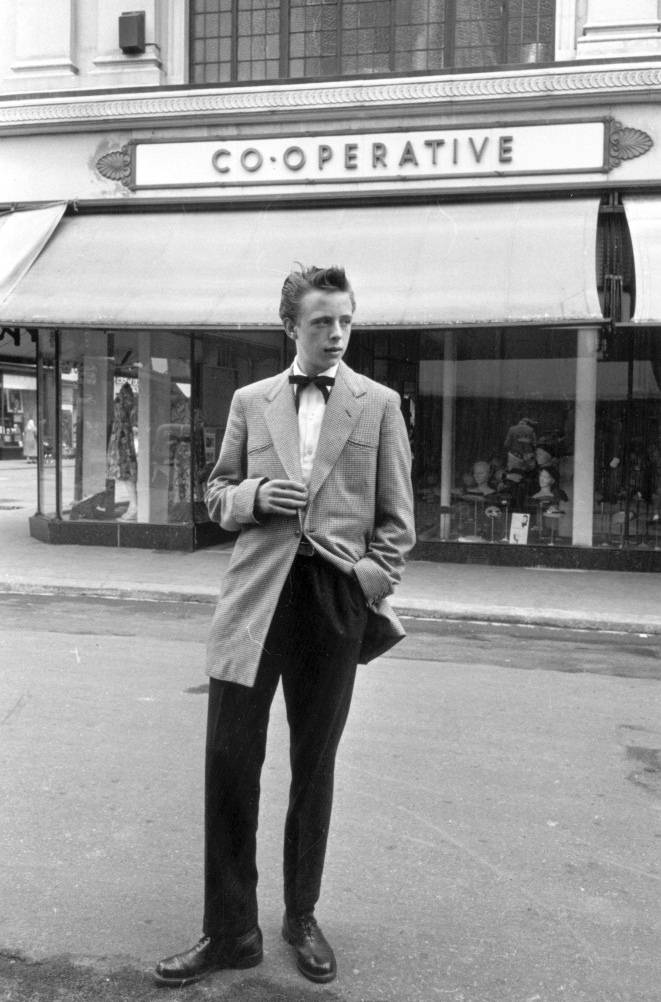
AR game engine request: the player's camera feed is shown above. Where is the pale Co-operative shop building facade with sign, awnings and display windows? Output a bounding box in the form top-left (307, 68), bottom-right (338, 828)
top-left (0, 0), bottom-right (661, 570)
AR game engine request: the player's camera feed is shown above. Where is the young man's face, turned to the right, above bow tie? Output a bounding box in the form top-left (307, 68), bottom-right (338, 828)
top-left (287, 289), bottom-right (354, 376)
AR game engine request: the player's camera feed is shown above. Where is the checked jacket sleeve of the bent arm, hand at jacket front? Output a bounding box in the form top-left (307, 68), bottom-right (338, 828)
top-left (204, 392), bottom-right (264, 532)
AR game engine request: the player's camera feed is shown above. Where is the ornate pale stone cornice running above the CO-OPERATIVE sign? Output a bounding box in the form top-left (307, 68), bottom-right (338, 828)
top-left (0, 60), bottom-right (661, 134)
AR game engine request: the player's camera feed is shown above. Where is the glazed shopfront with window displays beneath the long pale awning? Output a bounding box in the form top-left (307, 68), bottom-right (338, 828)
top-left (32, 327), bottom-right (661, 559)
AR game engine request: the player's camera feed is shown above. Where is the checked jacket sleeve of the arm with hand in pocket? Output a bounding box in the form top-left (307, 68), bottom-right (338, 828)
top-left (354, 394), bottom-right (416, 605)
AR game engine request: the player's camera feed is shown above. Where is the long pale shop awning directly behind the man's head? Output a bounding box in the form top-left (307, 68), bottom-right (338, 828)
top-left (0, 198), bottom-right (602, 328)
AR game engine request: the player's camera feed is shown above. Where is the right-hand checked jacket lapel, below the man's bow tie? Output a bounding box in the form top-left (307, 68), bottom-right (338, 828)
top-left (308, 362), bottom-right (366, 504)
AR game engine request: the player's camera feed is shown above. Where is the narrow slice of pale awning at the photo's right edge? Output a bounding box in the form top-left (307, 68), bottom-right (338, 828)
top-left (622, 195), bottom-right (661, 325)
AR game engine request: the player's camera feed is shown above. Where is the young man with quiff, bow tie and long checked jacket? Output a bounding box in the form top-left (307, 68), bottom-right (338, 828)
top-left (155, 268), bottom-right (415, 987)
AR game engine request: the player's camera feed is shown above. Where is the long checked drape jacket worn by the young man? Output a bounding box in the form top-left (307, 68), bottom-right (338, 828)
top-left (205, 362), bottom-right (415, 685)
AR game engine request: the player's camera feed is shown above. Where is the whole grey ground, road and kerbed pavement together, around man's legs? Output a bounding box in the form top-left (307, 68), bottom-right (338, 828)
top-left (0, 464), bottom-right (661, 1002)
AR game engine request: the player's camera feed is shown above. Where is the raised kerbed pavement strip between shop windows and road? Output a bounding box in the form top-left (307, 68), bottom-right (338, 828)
top-left (0, 461), bottom-right (661, 634)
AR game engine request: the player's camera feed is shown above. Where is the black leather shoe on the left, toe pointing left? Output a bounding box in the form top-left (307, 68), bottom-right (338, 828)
top-left (154, 926), bottom-right (262, 988)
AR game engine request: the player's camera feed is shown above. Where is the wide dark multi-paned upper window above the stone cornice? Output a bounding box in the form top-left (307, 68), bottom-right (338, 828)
top-left (190, 0), bottom-right (555, 83)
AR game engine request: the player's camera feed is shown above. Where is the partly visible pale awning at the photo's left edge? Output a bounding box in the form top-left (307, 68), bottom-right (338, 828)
top-left (0, 202), bottom-right (66, 303)
